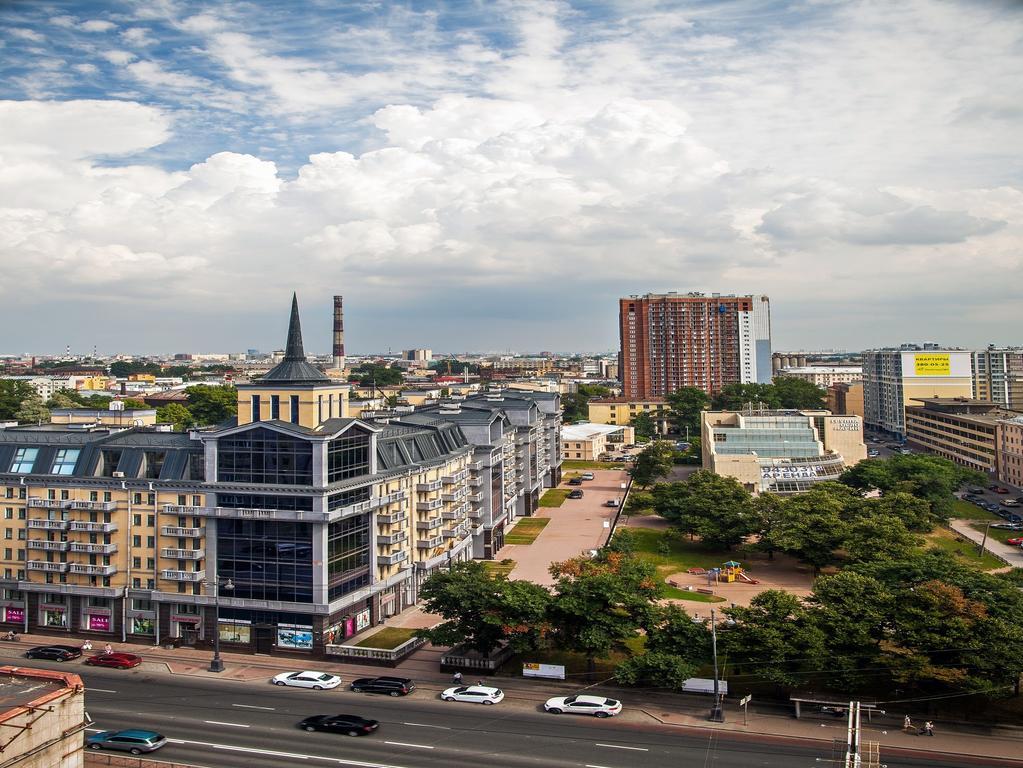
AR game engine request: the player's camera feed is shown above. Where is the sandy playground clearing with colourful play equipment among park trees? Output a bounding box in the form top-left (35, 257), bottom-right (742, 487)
top-left (667, 555), bottom-right (812, 605)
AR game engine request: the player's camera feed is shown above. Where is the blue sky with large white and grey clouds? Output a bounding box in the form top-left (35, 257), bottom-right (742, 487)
top-left (0, 0), bottom-right (1023, 354)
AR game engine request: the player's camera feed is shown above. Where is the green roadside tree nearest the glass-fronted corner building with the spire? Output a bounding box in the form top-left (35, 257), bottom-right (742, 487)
top-left (420, 560), bottom-right (550, 654)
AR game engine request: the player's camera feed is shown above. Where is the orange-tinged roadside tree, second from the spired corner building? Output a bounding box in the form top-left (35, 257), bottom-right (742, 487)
top-left (547, 549), bottom-right (661, 672)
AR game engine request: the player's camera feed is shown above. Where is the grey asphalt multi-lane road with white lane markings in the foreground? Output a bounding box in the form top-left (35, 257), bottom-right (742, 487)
top-left (0, 650), bottom-right (1002, 768)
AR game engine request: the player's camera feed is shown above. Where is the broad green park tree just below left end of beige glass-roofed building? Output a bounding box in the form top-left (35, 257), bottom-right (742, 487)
top-left (653, 469), bottom-right (757, 549)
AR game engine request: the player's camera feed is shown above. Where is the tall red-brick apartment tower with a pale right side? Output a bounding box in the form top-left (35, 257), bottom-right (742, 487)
top-left (619, 292), bottom-right (771, 400)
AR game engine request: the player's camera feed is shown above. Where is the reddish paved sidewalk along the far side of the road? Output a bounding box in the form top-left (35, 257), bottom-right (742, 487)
top-left (0, 635), bottom-right (1023, 766)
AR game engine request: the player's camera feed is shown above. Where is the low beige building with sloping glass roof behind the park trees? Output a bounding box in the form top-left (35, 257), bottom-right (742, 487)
top-left (701, 410), bottom-right (866, 495)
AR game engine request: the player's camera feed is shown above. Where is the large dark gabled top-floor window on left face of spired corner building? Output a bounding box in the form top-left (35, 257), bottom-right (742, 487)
top-left (217, 428), bottom-right (313, 486)
